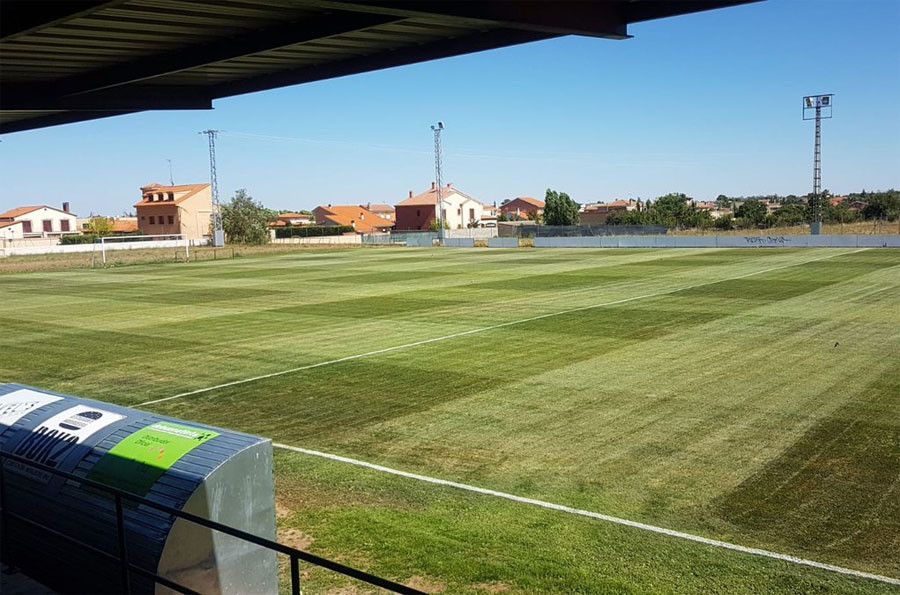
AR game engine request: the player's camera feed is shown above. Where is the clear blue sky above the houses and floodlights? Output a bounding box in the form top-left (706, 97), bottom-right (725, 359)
top-left (0, 0), bottom-right (900, 215)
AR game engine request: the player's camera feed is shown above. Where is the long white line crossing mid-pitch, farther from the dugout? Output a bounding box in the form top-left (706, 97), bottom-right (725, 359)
top-left (135, 248), bottom-right (868, 407)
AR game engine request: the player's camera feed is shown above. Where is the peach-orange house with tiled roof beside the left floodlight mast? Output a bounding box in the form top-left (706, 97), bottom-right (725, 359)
top-left (134, 184), bottom-right (212, 240)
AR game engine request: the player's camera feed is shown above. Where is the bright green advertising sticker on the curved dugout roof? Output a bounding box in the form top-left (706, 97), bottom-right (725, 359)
top-left (88, 421), bottom-right (219, 496)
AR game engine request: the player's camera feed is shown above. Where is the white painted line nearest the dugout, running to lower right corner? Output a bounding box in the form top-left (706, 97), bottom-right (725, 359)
top-left (273, 442), bottom-right (900, 585)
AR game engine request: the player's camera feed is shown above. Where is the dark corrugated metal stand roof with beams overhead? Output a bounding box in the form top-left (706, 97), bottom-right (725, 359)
top-left (0, 0), bottom-right (756, 133)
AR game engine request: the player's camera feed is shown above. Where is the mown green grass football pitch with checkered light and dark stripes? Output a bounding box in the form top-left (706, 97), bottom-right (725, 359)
top-left (0, 249), bottom-right (900, 593)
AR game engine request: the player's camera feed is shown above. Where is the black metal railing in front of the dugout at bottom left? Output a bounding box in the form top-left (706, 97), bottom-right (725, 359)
top-left (0, 452), bottom-right (424, 595)
